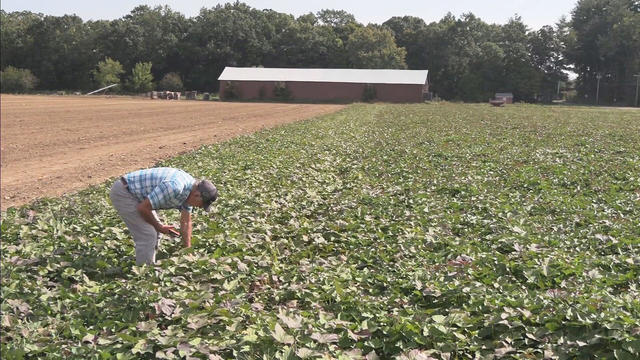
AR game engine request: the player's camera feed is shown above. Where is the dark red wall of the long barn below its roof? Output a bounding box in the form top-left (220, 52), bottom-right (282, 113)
top-left (220, 81), bottom-right (423, 102)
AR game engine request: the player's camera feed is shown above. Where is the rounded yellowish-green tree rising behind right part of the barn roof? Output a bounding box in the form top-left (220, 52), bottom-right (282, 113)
top-left (345, 25), bottom-right (407, 69)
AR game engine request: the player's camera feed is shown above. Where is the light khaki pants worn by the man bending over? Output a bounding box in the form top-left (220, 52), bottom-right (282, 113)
top-left (109, 179), bottom-right (161, 265)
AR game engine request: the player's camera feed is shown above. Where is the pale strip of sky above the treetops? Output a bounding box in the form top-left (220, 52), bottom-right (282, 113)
top-left (0, 0), bottom-right (577, 30)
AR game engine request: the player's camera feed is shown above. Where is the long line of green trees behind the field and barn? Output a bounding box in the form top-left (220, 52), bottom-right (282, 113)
top-left (0, 0), bottom-right (640, 105)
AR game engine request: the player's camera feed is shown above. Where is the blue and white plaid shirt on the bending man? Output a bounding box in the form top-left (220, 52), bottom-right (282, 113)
top-left (124, 168), bottom-right (196, 212)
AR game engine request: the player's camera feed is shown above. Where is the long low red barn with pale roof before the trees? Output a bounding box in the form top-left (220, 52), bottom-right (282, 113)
top-left (218, 67), bottom-right (429, 102)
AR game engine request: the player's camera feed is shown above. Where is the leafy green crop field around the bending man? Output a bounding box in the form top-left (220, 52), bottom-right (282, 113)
top-left (0, 103), bottom-right (640, 359)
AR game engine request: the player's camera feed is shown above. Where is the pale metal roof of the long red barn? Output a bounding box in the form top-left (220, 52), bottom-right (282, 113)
top-left (218, 66), bottom-right (429, 85)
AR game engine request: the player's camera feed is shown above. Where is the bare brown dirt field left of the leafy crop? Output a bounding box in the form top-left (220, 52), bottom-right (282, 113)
top-left (0, 95), bottom-right (344, 210)
